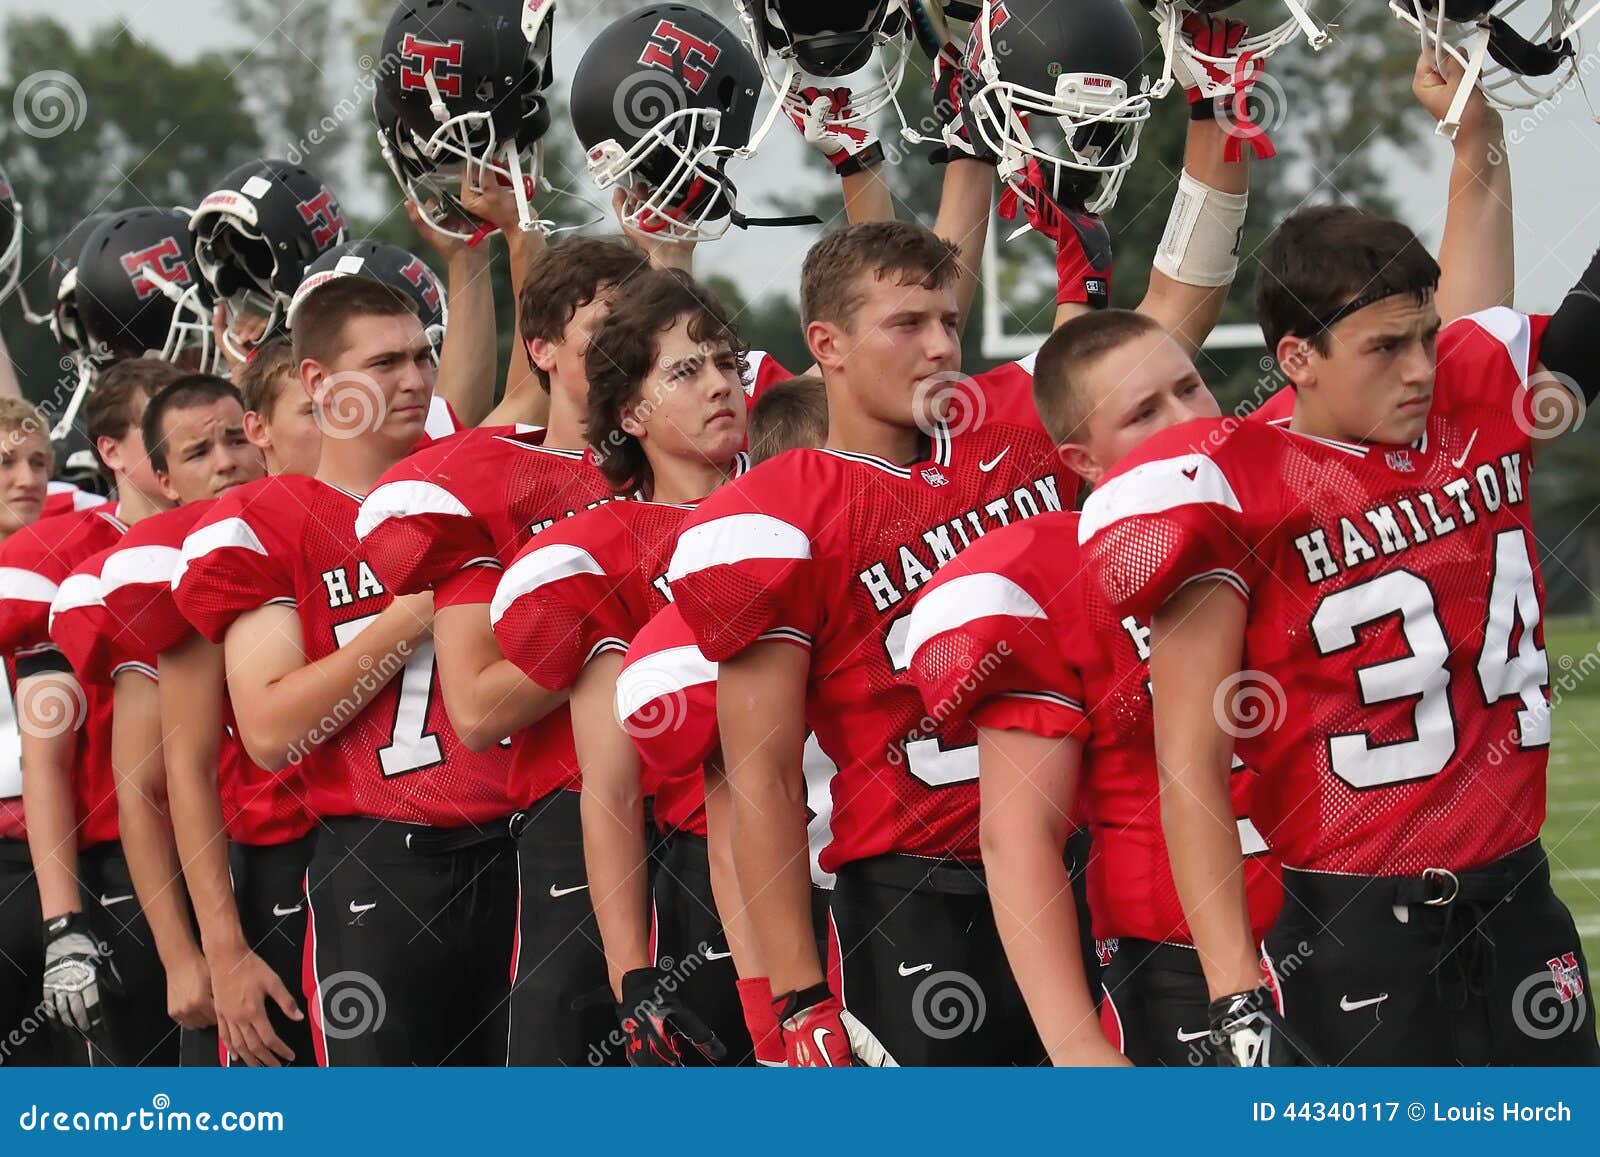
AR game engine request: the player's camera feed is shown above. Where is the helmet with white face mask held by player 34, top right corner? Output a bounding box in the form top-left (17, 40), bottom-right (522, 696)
top-left (1389, 0), bottom-right (1580, 138)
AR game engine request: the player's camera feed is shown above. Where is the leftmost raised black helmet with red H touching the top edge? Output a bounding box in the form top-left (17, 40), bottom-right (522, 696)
top-left (373, 0), bottom-right (555, 237)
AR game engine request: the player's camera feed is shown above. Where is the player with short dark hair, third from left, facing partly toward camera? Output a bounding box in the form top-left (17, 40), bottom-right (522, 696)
top-left (50, 374), bottom-right (266, 1066)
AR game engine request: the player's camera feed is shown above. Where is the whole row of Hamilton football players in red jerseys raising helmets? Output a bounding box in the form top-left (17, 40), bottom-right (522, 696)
top-left (0, 0), bottom-right (1600, 1066)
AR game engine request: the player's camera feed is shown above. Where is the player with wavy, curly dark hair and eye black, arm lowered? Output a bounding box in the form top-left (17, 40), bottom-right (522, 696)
top-left (490, 270), bottom-right (750, 1064)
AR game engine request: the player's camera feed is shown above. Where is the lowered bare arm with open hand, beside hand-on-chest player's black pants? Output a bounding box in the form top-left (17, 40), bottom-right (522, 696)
top-left (160, 634), bottom-right (304, 1066)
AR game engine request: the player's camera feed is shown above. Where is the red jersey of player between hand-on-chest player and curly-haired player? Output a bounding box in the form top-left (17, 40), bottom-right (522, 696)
top-left (355, 427), bottom-right (616, 803)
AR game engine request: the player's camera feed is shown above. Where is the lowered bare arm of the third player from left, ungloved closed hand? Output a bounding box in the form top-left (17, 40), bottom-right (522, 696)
top-left (110, 671), bottom-right (216, 1029)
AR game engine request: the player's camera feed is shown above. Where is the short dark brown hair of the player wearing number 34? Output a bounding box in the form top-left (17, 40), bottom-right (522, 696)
top-left (1256, 205), bottom-right (1438, 355)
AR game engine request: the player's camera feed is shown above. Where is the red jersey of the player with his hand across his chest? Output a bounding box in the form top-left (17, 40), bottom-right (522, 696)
top-left (173, 475), bottom-right (512, 827)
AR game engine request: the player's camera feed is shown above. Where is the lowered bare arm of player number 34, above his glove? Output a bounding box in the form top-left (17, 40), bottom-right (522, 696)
top-left (1150, 583), bottom-right (1261, 1000)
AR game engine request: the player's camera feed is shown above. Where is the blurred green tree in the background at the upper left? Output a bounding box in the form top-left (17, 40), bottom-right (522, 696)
top-left (0, 16), bottom-right (261, 412)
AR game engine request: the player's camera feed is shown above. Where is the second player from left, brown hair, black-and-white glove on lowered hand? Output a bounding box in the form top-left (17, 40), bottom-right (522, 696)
top-left (0, 358), bottom-right (182, 1066)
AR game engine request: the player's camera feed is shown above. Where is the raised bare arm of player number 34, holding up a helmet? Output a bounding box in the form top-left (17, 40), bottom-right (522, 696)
top-left (1411, 53), bottom-right (1517, 323)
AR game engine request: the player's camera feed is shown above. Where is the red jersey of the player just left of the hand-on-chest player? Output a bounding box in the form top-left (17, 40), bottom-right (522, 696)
top-left (99, 499), bottom-right (315, 845)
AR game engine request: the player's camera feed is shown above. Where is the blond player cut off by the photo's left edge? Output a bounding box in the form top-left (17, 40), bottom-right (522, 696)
top-left (0, 397), bottom-right (85, 1064)
